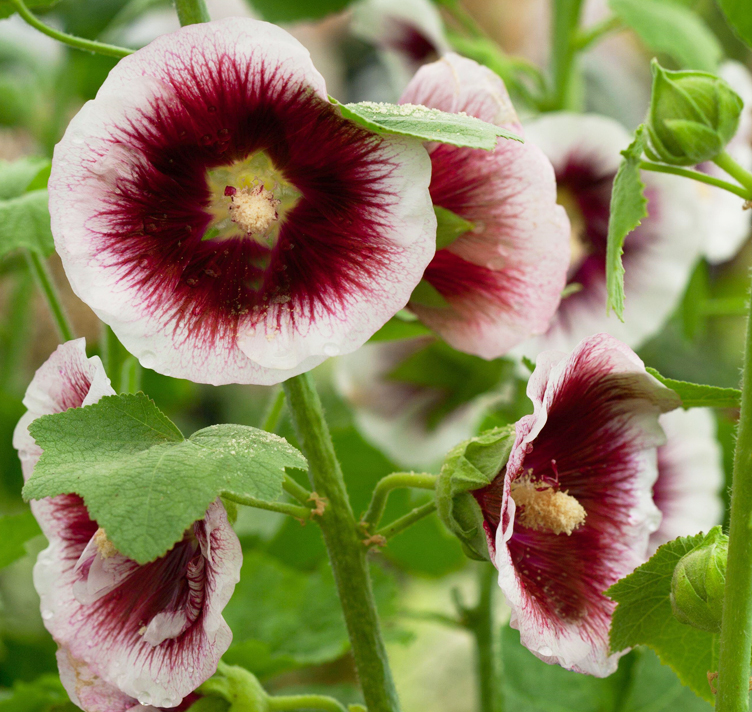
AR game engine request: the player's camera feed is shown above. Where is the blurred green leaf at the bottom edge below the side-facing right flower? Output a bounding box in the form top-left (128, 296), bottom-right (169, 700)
top-left (501, 627), bottom-right (711, 712)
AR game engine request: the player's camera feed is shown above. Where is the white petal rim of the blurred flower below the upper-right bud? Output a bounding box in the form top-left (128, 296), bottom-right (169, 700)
top-left (519, 112), bottom-right (706, 357)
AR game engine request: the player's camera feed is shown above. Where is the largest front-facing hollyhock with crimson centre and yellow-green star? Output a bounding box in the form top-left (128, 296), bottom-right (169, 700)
top-left (49, 18), bottom-right (436, 384)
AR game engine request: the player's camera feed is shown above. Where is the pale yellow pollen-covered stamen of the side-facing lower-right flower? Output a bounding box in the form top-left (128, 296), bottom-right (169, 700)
top-left (511, 473), bottom-right (587, 536)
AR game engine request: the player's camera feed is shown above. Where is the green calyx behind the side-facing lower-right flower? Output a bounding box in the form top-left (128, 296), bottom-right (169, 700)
top-left (436, 426), bottom-right (515, 561)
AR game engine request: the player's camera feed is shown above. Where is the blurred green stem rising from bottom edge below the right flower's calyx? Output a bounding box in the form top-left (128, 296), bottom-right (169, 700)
top-left (464, 564), bottom-right (503, 712)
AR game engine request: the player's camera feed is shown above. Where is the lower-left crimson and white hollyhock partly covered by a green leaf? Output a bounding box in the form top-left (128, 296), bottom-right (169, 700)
top-left (13, 339), bottom-right (242, 712)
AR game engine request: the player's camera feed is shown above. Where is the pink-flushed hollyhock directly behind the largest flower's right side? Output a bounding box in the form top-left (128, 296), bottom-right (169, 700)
top-left (401, 54), bottom-right (569, 359)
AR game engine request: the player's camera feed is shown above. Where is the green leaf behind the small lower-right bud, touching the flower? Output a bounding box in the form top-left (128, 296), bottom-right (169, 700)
top-left (606, 534), bottom-right (718, 702)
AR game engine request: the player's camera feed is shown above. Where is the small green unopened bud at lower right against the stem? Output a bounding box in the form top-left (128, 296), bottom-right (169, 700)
top-left (671, 527), bottom-right (728, 633)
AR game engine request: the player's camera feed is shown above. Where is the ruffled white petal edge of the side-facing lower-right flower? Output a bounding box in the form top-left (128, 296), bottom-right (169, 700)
top-left (494, 334), bottom-right (680, 677)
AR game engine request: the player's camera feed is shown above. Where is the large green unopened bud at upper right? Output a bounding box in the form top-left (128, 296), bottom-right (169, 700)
top-left (645, 60), bottom-right (744, 166)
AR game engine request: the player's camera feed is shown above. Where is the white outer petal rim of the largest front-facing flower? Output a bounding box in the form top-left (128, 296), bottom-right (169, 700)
top-left (49, 18), bottom-right (436, 385)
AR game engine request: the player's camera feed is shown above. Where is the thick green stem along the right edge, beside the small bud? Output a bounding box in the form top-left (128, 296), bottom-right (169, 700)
top-left (715, 286), bottom-right (752, 712)
